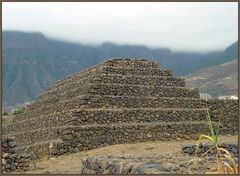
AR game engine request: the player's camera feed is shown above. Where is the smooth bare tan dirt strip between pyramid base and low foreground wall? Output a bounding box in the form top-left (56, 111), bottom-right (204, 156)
top-left (23, 136), bottom-right (238, 174)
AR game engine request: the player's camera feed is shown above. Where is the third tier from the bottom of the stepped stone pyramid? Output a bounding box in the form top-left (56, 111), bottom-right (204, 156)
top-left (7, 95), bottom-right (206, 125)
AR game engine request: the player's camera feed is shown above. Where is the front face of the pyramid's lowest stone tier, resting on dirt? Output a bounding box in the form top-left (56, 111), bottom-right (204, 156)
top-left (15, 121), bottom-right (208, 156)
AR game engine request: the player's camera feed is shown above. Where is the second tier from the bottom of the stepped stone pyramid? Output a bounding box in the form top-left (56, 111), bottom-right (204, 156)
top-left (3, 108), bottom-right (206, 135)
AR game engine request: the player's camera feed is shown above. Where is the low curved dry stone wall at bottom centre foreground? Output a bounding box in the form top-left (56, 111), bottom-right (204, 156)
top-left (81, 156), bottom-right (174, 175)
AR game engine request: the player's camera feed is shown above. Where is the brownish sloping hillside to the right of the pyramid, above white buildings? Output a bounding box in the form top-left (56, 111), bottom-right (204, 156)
top-left (185, 59), bottom-right (238, 97)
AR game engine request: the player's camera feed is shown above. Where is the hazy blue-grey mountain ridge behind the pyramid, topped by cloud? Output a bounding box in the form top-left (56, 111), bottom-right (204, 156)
top-left (2, 31), bottom-right (238, 108)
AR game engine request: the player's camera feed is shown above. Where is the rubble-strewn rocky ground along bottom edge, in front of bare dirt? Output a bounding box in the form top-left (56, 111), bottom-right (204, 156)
top-left (82, 153), bottom-right (237, 174)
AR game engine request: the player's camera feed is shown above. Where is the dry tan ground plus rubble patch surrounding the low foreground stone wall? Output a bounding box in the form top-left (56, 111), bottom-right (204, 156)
top-left (13, 136), bottom-right (238, 174)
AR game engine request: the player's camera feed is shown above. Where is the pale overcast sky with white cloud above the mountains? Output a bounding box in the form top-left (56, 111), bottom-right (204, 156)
top-left (2, 2), bottom-right (238, 52)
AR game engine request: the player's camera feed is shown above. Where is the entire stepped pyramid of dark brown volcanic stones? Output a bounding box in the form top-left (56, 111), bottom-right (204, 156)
top-left (3, 59), bottom-right (208, 158)
